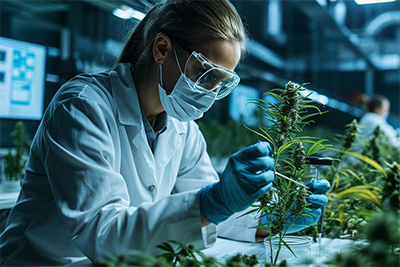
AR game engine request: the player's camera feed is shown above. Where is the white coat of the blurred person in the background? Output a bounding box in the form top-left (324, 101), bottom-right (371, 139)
top-left (359, 112), bottom-right (400, 147)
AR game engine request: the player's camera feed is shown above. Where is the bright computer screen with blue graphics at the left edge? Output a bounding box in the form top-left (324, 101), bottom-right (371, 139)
top-left (0, 37), bottom-right (46, 120)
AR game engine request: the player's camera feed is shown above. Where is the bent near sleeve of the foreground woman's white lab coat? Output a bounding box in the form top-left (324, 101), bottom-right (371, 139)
top-left (41, 97), bottom-right (209, 262)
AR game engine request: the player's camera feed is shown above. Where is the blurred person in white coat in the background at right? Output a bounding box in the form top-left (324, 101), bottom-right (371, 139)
top-left (359, 95), bottom-right (400, 147)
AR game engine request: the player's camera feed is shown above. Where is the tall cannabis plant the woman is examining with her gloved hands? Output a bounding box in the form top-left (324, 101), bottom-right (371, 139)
top-left (245, 82), bottom-right (332, 264)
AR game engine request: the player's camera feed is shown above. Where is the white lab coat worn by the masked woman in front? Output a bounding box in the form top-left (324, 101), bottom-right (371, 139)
top-left (0, 64), bottom-right (256, 265)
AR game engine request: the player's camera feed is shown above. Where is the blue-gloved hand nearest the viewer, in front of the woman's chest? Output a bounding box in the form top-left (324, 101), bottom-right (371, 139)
top-left (199, 142), bottom-right (275, 224)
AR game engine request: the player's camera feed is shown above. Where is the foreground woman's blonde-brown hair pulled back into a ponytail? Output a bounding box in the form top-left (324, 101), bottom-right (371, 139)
top-left (117, 0), bottom-right (246, 73)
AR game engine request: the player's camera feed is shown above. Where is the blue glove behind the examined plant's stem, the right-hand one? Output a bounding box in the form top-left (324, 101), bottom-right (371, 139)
top-left (261, 179), bottom-right (331, 234)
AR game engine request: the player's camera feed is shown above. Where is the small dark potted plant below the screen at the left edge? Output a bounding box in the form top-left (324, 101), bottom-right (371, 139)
top-left (4, 121), bottom-right (30, 192)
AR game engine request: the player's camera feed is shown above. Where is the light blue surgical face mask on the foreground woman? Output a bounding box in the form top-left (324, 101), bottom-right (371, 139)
top-left (158, 46), bottom-right (217, 122)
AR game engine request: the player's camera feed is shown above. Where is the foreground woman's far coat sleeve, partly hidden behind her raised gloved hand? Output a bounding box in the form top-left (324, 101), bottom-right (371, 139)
top-left (175, 122), bottom-right (257, 242)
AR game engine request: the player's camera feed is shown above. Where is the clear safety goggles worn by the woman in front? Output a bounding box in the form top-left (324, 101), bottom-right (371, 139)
top-left (182, 51), bottom-right (240, 99)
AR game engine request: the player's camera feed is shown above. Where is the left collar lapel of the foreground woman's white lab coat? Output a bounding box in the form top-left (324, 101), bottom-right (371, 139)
top-left (110, 63), bottom-right (142, 127)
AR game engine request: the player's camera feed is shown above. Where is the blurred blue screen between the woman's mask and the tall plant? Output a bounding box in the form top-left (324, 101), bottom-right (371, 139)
top-left (229, 84), bottom-right (260, 125)
